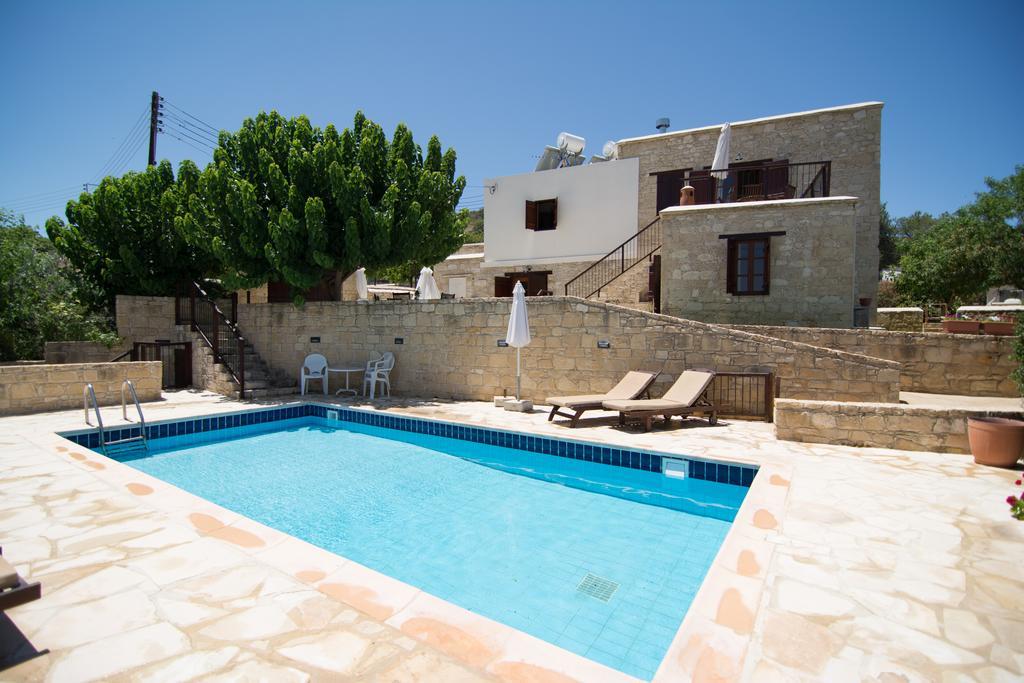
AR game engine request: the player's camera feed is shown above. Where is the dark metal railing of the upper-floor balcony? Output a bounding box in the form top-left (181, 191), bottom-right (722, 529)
top-left (685, 161), bottom-right (831, 204)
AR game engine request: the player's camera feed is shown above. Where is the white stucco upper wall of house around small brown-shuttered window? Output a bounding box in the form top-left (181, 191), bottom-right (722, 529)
top-left (483, 159), bottom-right (640, 263)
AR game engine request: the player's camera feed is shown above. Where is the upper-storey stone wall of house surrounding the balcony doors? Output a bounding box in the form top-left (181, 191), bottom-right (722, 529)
top-left (618, 102), bottom-right (882, 321)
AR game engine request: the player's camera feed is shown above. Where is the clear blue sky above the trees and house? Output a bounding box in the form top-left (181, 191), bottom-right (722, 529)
top-left (0, 0), bottom-right (1024, 225)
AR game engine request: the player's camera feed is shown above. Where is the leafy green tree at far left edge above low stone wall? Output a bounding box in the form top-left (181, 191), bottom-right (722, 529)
top-left (0, 209), bottom-right (117, 360)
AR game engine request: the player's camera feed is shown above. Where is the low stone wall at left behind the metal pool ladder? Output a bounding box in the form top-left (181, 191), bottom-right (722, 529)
top-left (0, 360), bottom-right (162, 415)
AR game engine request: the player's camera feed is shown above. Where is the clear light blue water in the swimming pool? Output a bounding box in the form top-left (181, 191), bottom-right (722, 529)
top-left (119, 417), bottom-right (746, 679)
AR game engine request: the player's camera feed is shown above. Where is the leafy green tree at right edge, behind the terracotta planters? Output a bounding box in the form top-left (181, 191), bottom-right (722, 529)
top-left (896, 166), bottom-right (1024, 305)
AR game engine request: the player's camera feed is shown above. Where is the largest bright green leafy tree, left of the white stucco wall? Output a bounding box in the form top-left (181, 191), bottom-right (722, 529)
top-left (177, 112), bottom-right (467, 300)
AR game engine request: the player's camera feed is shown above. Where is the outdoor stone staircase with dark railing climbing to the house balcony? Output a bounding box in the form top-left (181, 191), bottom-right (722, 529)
top-left (565, 217), bottom-right (662, 310)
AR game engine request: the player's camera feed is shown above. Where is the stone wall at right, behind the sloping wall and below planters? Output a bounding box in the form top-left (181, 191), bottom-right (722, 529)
top-left (733, 326), bottom-right (1020, 397)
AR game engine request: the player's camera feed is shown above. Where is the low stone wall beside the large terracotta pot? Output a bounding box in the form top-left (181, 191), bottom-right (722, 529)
top-left (775, 399), bottom-right (1024, 453)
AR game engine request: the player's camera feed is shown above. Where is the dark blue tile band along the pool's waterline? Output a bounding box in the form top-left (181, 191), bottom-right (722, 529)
top-left (59, 402), bottom-right (758, 487)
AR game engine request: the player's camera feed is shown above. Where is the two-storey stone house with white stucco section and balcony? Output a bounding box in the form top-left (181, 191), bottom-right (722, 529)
top-left (434, 102), bottom-right (883, 327)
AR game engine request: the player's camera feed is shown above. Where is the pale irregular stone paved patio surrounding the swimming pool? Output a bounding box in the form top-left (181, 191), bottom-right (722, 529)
top-left (0, 392), bottom-right (1024, 681)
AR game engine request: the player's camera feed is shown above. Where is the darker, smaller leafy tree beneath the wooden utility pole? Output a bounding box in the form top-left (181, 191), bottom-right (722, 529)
top-left (46, 161), bottom-right (213, 305)
